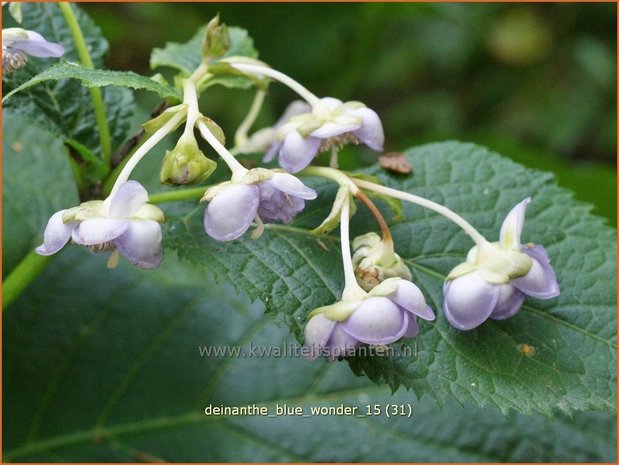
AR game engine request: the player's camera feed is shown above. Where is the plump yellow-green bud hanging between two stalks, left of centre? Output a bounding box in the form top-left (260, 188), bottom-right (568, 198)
top-left (159, 137), bottom-right (217, 186)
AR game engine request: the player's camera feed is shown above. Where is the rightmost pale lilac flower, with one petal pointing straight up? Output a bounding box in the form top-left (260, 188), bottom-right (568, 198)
top-left (443, 198), bottom-right (559, 330)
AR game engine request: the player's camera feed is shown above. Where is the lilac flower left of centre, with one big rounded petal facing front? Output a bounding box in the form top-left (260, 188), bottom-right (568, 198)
top-left (204, 173), bottom-right (317, 241)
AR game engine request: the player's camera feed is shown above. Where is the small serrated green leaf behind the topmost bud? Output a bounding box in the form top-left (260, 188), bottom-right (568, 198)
top-left (150, 26), bottom-right (258, 89)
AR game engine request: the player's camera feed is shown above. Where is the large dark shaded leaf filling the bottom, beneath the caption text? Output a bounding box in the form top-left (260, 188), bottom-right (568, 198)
top-left (3, 248), bottom-right (616, 462)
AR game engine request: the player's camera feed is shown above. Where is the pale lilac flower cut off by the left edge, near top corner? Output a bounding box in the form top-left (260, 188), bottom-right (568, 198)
top-left (2, 27), bottom-right (64, 71)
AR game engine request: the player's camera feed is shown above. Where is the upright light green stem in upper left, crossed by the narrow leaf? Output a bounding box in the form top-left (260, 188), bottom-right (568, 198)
top-left (58, 2), bottom-right (112, 166)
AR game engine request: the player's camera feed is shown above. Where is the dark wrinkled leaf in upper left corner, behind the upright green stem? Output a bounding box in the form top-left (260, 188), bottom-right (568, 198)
top-left (2, 2), bottom-right (133, 153)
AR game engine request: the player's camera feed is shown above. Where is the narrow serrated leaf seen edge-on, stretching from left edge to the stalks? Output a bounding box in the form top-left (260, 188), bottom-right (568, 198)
top-left (2, 63), bottom-right (181, 103)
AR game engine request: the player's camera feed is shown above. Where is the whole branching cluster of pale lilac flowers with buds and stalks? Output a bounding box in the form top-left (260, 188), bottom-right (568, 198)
top-left (21, 10), bottom-right (559, 359)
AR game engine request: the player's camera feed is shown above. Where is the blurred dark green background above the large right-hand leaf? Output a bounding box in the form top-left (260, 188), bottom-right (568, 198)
top-left (82, 3), bottom-right (617, 225)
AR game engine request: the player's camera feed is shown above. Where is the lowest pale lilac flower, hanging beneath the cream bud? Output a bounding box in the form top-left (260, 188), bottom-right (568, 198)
top-left (305, 278), bottom-right (435, 360)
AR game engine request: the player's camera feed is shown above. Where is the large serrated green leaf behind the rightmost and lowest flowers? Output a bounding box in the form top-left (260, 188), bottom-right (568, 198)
top-left (167, 143), bottom-right (616, 415)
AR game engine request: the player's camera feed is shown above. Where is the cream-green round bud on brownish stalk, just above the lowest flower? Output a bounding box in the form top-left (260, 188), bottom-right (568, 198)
top-left (352, 232), bottom-right (411, 291)
